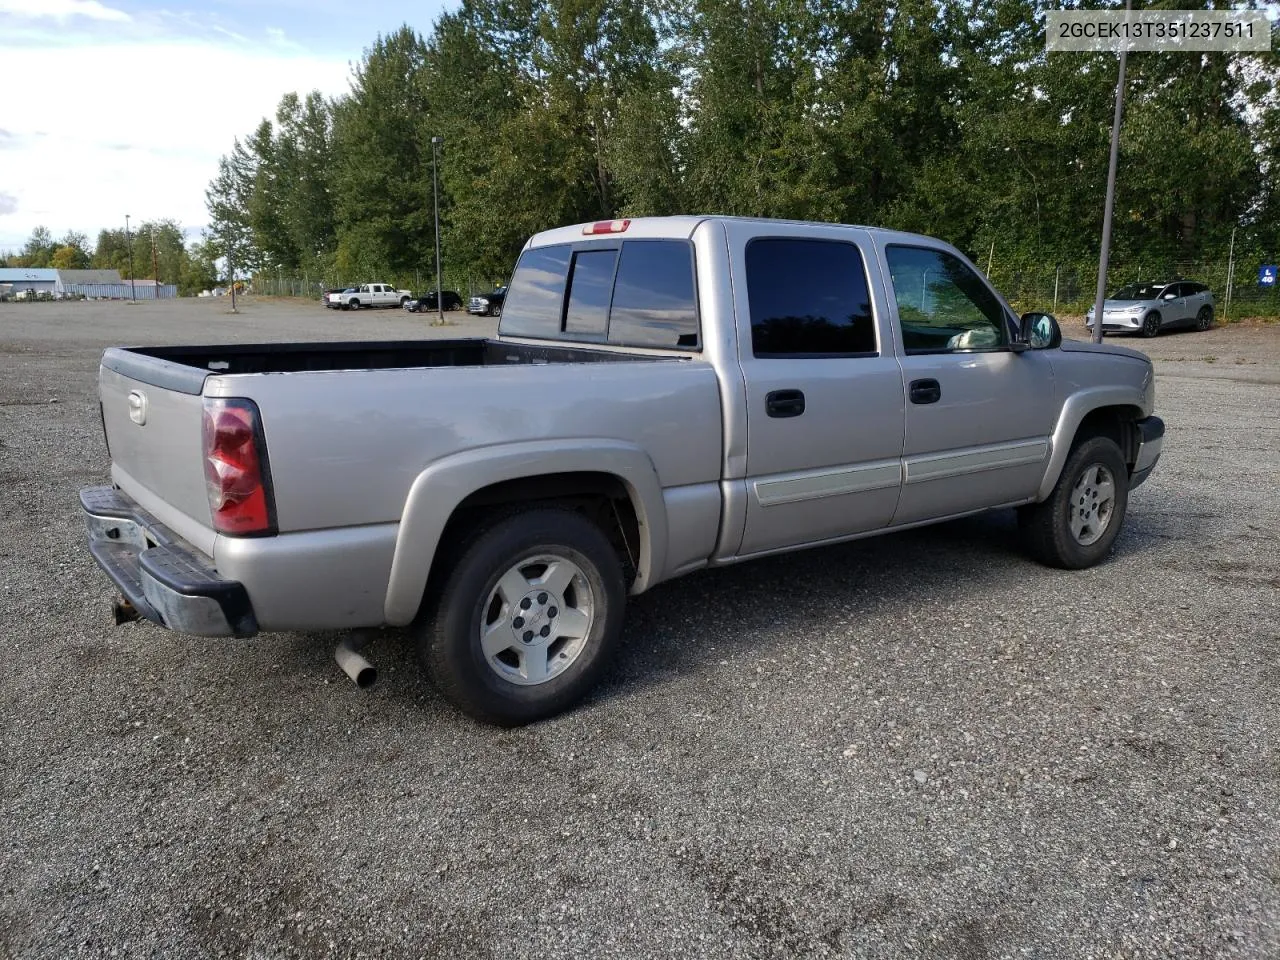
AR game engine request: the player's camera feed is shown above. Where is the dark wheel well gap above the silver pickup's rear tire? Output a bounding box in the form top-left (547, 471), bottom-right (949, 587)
top-left (428, 471), bottom-right (640, 601)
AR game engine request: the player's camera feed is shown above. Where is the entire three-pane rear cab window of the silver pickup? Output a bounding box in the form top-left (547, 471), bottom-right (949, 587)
top-left (499, 239), bottom-right (700, 349)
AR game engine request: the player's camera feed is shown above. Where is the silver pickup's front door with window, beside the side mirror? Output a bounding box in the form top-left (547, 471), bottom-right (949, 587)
top-left (883, 244), bottom-right (1055, 525)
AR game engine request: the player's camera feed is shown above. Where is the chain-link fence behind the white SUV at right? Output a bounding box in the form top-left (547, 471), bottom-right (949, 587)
top-left (978, 257), bottom-right (1280, 320)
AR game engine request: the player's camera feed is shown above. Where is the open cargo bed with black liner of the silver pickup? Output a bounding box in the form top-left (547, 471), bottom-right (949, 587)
top-left (102, 338), bottom-right (663, 394)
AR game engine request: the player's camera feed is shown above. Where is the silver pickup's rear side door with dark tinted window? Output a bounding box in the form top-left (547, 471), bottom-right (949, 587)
top-left (726, 221), bottom-right (904, 556)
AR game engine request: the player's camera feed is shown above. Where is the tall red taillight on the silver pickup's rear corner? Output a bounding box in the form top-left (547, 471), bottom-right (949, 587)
top-left (205, 398), bottom-right (275, 536)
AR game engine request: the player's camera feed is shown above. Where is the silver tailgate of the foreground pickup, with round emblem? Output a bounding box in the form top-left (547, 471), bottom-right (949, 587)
top-left (99, 351), bottom-right (212, 529)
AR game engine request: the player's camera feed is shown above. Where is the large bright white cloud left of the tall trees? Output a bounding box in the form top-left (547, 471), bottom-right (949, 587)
top-left (0, 40), bottom-right (349, 251)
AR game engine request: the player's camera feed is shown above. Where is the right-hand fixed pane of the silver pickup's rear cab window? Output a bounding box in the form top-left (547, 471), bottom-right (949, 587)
top-left (609, 241), bottom-right (698, 348)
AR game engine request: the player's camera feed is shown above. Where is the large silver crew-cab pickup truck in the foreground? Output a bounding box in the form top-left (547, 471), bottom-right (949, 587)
top-left (81, 216), bottom-right (1164, 724)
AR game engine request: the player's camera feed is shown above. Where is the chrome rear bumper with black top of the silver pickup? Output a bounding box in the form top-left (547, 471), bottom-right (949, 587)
top-left (81, 486), bottom-right (259, 636)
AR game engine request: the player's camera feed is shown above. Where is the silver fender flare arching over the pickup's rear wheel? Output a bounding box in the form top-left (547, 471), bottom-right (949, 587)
top-left (384, 439), bottom-right (667, 626)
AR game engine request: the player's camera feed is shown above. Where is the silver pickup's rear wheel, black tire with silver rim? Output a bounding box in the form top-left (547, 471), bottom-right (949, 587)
top-left (419, 508), bottom-right (626, 727)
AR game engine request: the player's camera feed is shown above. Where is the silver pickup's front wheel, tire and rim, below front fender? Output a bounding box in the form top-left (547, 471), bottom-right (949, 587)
top-left (1018, 436), bottom-right (1129, 570)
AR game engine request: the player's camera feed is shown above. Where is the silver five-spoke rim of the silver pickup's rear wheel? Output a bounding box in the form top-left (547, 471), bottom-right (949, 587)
top-left (480, 553), bottom-right (595, 686)
